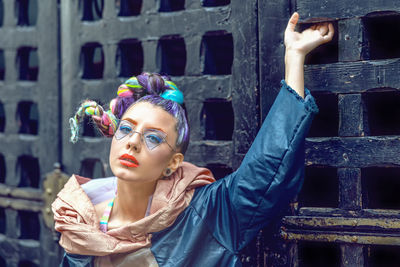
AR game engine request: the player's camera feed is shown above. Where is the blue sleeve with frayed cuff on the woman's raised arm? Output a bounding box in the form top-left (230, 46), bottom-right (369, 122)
top-left (193, 81), bottom-right (318, 251)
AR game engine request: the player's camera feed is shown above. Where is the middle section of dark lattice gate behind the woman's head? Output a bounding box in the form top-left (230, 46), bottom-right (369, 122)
top-left (61, 0), bottom-right (258, 184)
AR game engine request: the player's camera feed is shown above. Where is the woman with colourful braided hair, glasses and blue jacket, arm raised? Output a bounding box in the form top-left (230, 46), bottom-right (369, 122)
top-left (53, 13), bottom-right (334, 266)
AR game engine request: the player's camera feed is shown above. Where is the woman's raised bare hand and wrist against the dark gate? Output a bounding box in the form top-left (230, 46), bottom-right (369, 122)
top-left (285, 12), bottom-right (335, 98)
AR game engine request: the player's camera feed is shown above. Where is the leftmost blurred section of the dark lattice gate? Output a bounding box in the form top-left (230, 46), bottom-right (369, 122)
top-left (0, 0), bottom-right (59, 266)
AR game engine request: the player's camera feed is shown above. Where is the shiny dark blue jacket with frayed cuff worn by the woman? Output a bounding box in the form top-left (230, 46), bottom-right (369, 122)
top-left (62, 82), bottom-right (318, 267)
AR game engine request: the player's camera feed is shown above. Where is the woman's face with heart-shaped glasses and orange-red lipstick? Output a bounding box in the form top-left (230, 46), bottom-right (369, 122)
top-left (110, 102), bottom-right (177, 183)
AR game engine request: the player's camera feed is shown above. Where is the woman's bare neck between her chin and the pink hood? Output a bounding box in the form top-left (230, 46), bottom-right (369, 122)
top-left (112, 179), bottom-right (157, 224)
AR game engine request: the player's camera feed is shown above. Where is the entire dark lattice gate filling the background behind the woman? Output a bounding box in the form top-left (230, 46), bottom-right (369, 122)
top-left (0, 0), bottom-right (400, 266)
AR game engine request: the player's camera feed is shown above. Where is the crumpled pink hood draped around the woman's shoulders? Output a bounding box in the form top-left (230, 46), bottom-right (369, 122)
top-left (52, 162), bottom-right (215, 256)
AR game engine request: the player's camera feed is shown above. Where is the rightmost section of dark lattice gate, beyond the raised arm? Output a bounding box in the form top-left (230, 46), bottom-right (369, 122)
top-left (262, 0), bottom-right (400, 266)
